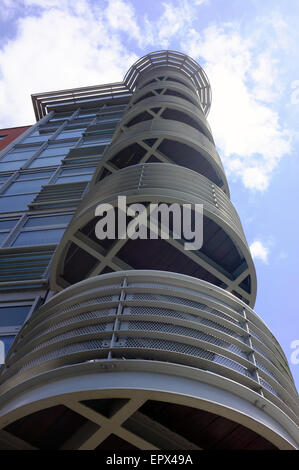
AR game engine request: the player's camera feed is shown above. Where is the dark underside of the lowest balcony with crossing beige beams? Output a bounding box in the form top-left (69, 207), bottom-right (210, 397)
top-left (0, 380), bottom-right (293, 451)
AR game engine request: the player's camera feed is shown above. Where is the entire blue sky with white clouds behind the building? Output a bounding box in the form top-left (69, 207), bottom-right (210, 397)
top-left (0, 0), bottom-right (299, 387)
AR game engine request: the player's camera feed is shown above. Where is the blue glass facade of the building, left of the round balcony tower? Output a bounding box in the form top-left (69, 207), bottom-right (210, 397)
top-left (0, 97), bottom-right (129, 353)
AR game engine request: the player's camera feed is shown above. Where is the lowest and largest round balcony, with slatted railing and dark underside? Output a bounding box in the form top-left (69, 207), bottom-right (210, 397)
top-left (0, 271), bottom-right (299, 450)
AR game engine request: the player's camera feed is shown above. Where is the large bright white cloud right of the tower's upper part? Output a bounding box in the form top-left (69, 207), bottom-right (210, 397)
top-left (184, 24), bottom-right (292, 191)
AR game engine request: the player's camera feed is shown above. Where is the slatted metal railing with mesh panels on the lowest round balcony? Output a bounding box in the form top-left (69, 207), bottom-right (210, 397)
top-left (0, 271), bottom-right (298, 442)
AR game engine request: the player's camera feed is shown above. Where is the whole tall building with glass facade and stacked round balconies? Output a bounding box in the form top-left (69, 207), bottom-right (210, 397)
top-left (0, 51), bottom-right (299, 450)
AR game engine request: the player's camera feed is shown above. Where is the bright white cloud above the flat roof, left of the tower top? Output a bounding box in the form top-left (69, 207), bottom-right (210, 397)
top-left (0, 0), bottom-right (138, 127)
